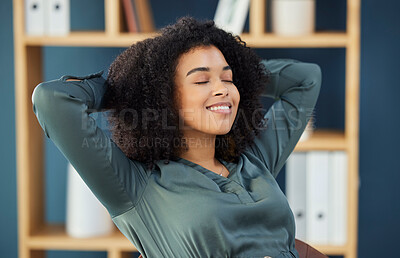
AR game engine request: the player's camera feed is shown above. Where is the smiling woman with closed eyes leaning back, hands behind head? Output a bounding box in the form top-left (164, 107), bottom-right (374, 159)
top-left (32, 17), bottom-right (321, 257)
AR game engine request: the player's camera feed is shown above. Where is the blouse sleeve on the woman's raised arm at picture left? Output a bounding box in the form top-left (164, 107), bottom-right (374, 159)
top-left (32, 72), bottom-right (148, 217)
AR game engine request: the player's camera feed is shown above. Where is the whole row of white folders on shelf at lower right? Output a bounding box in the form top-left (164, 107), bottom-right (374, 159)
top-left (286, 151), bottom-right (347, 245)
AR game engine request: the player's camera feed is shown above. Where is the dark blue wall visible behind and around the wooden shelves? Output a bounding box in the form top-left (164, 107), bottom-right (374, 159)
top-left (0, 0), bottom-right (400, 258)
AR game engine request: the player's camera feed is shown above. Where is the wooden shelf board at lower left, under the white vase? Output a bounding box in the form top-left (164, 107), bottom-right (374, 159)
top-left (27, 224), bottom-right (137, 252)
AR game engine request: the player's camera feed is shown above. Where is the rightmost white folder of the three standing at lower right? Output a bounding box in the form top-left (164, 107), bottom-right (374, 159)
top-left (329, 151), bottom-right (347, 245)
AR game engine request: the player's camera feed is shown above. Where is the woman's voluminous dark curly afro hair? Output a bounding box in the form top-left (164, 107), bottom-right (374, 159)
top-left (104, 17), bottom-right (269, 168)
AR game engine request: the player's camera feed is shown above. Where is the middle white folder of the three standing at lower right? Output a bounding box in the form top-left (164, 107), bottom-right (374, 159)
top-left (306, 151), bottom-right (329, 244)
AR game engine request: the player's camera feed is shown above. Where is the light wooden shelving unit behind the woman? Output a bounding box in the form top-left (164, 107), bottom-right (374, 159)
top-left (13, 0), bottom-right (361, 258)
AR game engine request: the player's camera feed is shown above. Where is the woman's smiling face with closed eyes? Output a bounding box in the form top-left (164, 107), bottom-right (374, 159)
top-left (175, 46), bottom-right (240, 135)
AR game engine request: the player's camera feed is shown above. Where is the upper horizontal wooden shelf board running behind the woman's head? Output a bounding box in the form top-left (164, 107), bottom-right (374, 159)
top-left (24, 31), bottom-right (348, 48)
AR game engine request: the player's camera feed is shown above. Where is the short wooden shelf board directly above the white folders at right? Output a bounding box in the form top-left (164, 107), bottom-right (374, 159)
top-left (294, 130), bottom-right (347, 151)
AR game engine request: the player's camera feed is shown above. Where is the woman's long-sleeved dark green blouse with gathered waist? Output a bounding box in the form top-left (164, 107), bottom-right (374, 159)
top-left (32, 59), bottom-right (321, 258)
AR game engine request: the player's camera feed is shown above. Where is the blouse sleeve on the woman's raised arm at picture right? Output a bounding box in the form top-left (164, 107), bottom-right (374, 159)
top-left (250, 59), bottom-right (321, 178)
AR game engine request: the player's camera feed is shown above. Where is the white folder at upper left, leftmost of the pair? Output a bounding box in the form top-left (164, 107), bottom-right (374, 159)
top-left (24, 0), bottom-right (45, 36)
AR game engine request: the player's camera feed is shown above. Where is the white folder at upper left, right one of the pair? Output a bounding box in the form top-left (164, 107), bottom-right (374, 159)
top-left (45, 0), bottom-right (70, 36)
